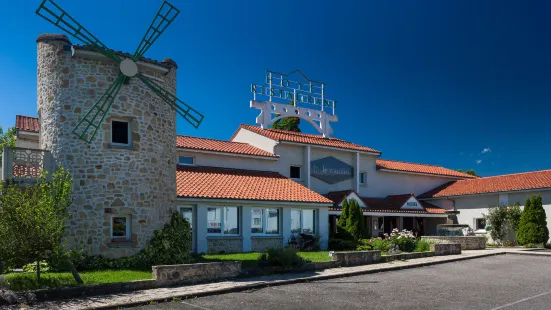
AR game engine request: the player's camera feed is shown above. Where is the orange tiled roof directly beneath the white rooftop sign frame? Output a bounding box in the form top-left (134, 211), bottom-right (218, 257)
top-left (230, 124), bottom-right (381, 154)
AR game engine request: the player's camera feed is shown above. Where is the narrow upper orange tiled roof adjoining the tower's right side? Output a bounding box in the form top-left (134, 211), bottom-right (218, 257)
top-left (176, 136), bottom-right (278, 157)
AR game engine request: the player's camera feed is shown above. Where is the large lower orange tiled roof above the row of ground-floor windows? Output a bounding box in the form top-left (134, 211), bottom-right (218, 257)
top-left (176, 166), bottom-right (332, 204)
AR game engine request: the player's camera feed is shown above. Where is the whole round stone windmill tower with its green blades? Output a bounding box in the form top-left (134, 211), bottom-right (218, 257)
top-left (36, 0), bottom-right (202, 257)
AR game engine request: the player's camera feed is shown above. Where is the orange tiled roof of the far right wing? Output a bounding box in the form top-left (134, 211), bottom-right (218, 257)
top-left (419, 170), bottom-right (551, 198)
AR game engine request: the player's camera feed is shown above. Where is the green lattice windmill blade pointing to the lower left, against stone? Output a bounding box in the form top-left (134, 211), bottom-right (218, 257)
top-left (73, 73), bottom-right (125, 143)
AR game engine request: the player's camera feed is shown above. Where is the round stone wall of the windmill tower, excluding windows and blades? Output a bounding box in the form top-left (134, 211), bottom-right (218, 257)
top-left (37, 35), bottom-right (177, 257)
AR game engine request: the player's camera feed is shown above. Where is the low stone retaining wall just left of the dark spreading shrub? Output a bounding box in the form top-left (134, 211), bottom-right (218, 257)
top-left (153, 262), bottom-right (241, 286)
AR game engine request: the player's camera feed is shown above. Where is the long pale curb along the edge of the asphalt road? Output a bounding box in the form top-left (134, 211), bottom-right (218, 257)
top-left (91, 251), bottom-right (508, 310)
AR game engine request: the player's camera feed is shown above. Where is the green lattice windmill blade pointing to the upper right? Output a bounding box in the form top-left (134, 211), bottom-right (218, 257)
top-left (132, 1), bottom-right (180, 61)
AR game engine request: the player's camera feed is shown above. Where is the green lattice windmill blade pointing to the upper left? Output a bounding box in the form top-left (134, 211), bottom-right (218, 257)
top-left (36, 0), bottom-right (121, 63)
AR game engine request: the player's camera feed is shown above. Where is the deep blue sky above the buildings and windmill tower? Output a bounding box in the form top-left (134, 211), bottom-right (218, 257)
top-left (0, 0), bottom-right (551, 176)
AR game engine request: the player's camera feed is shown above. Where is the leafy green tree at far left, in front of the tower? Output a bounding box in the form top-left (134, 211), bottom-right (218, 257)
top-left (0, 166), bottom-right (73, 280)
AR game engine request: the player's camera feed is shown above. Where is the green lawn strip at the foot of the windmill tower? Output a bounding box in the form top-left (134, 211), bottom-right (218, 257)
top-left (4, 270), bottom-right (152, 291)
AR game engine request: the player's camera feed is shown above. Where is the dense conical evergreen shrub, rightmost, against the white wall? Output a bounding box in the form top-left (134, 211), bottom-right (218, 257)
top-left (517, 195), bottom-right (549, 245)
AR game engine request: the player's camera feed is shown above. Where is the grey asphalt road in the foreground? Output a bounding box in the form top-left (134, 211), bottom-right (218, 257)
top-left (133, 255), bottom-right (551, 310)
